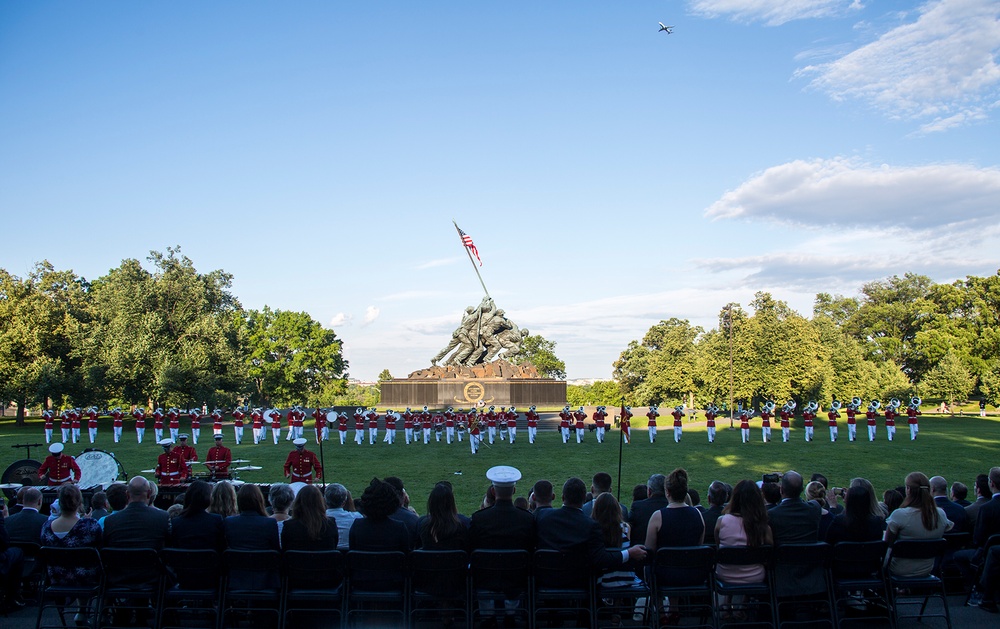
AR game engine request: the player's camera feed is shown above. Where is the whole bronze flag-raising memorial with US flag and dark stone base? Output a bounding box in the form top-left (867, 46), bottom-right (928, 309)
top-left (381, 225), bottom-right (566, 410)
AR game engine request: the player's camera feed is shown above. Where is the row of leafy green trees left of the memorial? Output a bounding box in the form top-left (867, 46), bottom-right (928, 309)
top-left (0, 247), bottom-right (350, 420)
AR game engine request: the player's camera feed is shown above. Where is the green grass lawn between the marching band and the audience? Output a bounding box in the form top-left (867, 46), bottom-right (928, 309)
top-left (0, 415), bottom-right (1000, 513)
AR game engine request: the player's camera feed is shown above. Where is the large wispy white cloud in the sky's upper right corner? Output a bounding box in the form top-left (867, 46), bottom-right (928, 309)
top-left (796, 0), bottom-right (1000, 126)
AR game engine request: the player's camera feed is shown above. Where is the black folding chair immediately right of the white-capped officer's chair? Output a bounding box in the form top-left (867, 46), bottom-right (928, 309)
top-left (532, 549), bottom-right (596, 627)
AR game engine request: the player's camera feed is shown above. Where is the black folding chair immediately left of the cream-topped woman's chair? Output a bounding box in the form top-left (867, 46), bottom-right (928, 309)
top-left (831, 540), bottom-right (895, 629)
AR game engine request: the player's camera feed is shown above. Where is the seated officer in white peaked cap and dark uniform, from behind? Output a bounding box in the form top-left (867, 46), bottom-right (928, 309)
top-left (469, 465), bottom-right (549, 626)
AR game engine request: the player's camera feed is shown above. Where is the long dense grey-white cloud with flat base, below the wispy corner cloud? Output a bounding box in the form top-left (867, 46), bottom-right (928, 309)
top-left (705, 158), bottom-right (1000, 230)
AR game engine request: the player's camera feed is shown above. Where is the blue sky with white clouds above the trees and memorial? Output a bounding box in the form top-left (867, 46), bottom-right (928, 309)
top-left (0, 0), bottom-right (1000, 379)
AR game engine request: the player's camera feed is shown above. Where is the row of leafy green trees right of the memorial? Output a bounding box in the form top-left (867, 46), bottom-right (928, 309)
top-left (569, 271), bottom-right (1000, 408)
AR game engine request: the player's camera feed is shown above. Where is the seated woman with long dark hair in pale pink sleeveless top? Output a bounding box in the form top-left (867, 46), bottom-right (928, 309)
top-left (715, 480), bottom-right (774, 583)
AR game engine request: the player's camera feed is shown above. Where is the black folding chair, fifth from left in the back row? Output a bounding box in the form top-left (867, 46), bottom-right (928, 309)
top-left (281, 550), bottom-right (347, 627)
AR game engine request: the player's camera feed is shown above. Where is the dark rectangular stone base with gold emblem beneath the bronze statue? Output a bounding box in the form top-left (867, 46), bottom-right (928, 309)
top-left (379, 378), bottom-right (566, 411)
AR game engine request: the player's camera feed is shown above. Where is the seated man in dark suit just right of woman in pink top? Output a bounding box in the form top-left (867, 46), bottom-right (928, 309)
top-left (767, 470), bottom-right (825, 597)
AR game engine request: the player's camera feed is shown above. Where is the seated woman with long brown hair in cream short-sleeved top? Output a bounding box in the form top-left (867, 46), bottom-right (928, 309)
top-left (885, 472), bottom-right (952, 577)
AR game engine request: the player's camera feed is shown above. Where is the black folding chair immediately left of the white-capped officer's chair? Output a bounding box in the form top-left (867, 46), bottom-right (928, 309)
top-left (410, 550), bottom-right (470, 626)
